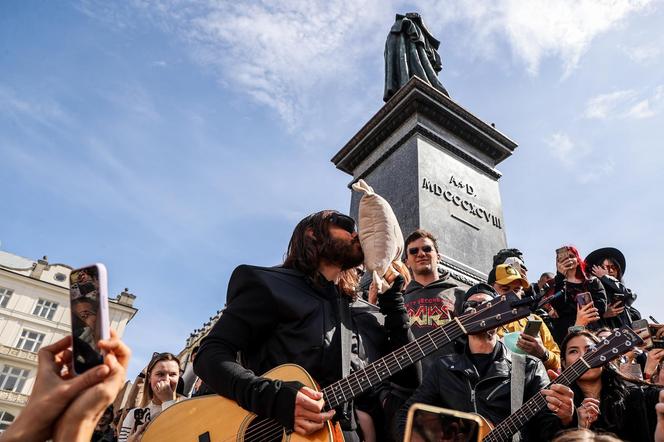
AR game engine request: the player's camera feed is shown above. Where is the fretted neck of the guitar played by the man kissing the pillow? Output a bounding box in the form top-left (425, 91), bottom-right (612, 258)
top-left (323, 318), bottom-right (465, 409)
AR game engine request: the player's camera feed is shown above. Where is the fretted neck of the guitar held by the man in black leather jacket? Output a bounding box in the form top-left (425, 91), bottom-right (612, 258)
top-left (483, 358), bottom-right (590, 442)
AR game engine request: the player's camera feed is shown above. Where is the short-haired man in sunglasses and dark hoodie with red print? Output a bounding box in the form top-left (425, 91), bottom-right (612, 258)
top-left (404, 229), bottom-right (464, 373)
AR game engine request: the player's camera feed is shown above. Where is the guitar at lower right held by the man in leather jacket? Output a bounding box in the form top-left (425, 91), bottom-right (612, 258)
top-left (480, 327), bottom-right (643, 442)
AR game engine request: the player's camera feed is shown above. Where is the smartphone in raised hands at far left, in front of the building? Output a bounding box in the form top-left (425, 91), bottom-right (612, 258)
top-left (69, 264), bottom-right (110, 374)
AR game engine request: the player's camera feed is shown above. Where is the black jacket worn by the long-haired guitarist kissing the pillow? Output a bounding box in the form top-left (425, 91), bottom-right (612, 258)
top-left (194, 265), bottom-right (419, 428)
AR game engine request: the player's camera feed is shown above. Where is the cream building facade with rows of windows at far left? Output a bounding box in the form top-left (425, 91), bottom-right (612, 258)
top-left (0, 251), bottom-right (137, 431)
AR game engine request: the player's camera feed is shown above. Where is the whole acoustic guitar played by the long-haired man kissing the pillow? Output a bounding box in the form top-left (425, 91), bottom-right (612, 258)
top-left (141, 293), bottom-right (539, 442)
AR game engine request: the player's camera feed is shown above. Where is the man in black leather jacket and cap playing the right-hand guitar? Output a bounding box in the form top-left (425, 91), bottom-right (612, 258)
top-left (398, 284), bottom-right (574, 441)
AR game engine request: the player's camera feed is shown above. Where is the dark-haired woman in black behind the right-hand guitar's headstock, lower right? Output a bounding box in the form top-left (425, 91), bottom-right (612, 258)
top-left (560, 330), bottom-right (660, 441)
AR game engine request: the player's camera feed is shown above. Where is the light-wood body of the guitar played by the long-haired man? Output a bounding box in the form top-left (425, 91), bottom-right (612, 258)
top-left (141, 364), bottom-right (343, 442)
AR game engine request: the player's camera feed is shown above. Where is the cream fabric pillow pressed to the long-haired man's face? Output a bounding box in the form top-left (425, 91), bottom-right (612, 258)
top-left (352, 180), bottom-right (403, 293)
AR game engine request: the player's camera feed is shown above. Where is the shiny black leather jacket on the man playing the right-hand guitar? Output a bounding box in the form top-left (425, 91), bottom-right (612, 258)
top-left (399, 341), bottom-right (562, 441)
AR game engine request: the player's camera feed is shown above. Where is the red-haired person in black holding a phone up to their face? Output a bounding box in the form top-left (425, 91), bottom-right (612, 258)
top-left (551, 246), bottom-right (606, 346)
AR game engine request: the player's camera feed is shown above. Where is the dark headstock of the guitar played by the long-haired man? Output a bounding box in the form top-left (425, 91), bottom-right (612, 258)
top-left (458, 292), bottom-right (531, 334)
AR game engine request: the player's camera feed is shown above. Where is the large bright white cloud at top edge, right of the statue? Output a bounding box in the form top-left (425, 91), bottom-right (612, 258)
top-left (416, 0), bottom-right (651, 76)
